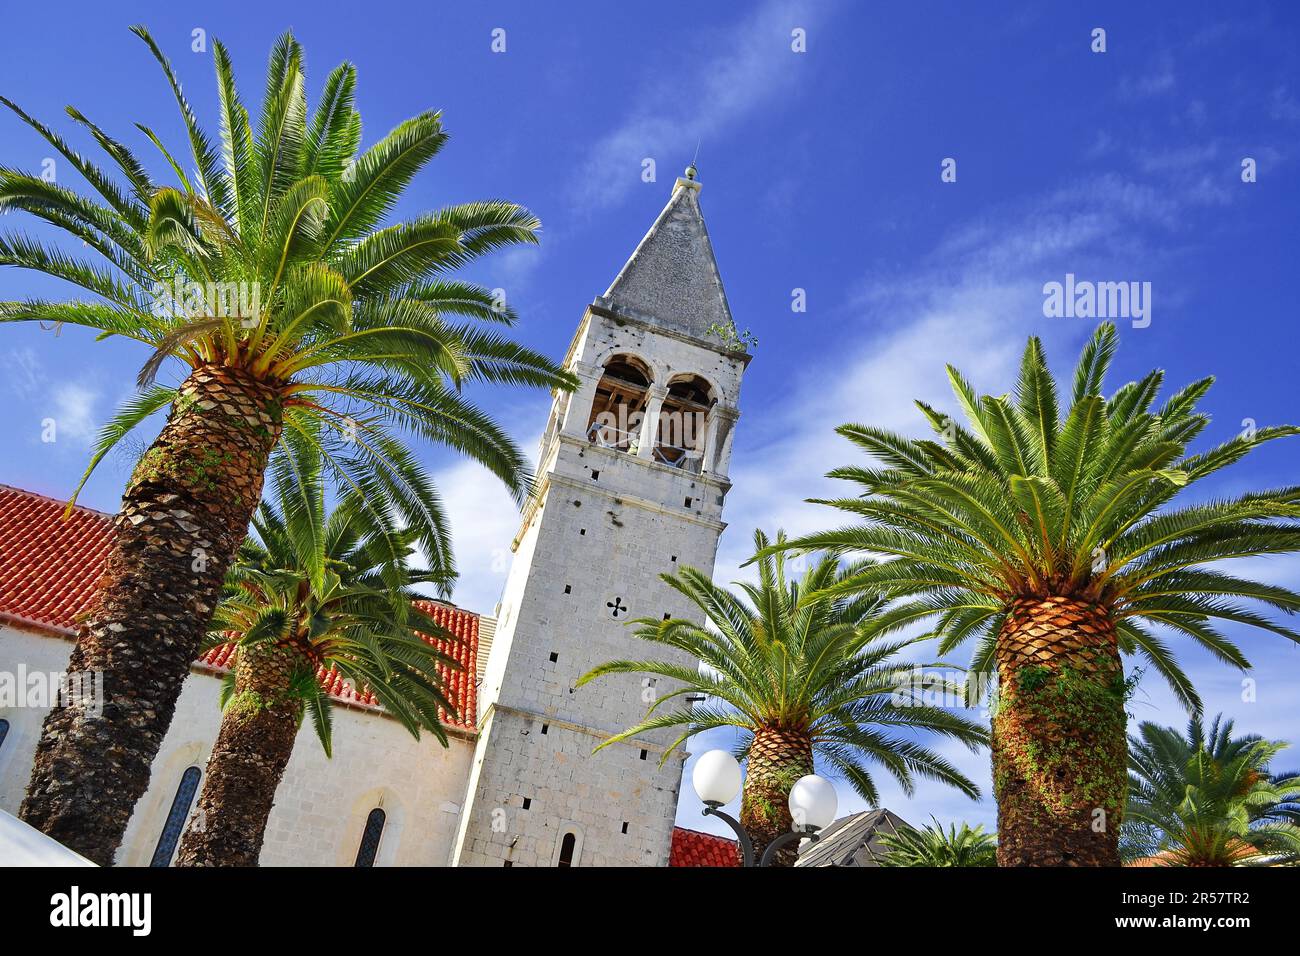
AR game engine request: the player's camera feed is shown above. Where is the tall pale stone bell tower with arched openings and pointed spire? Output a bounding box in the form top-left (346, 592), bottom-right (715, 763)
top-left (451, 166), bottom-right (750, 866)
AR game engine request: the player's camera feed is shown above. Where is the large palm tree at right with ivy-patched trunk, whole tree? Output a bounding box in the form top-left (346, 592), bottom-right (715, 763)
top-left (764, 324), bottom-right (1300, 866)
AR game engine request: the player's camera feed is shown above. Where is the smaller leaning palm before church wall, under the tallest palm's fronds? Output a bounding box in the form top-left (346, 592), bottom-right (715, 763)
top-left (177, 449), bottom-right (456, 866)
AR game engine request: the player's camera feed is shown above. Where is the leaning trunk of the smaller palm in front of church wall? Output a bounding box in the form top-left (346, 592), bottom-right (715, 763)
top-left (176, 643), bottom-right (306, 866)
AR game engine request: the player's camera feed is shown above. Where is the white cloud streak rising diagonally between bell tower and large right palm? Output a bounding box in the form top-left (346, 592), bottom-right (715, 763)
top-left (716, 174), bottom-right (1188, 590)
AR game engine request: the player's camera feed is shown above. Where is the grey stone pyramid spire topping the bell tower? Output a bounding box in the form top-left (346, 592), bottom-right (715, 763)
top-left (597, 164), bottom-right (733, 341)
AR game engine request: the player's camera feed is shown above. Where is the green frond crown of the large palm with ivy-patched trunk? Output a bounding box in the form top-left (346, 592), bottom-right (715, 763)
top-left (759, 324), bottom-right (1300, 709)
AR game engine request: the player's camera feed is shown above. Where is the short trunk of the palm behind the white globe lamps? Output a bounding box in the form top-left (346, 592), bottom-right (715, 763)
top-left (737, 727), bottom-right (813, 866)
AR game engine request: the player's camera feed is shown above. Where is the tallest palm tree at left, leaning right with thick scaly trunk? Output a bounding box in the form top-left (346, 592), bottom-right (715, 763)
top-left (0, 27), bottom-right (572, 864)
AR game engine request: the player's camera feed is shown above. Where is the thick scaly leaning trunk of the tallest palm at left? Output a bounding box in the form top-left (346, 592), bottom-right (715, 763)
top-left (18, 367), bottom-right (281, 866)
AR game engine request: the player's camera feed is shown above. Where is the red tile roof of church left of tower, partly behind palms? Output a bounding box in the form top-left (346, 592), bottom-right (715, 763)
top-left (0, 485), bottom-right (478, 730)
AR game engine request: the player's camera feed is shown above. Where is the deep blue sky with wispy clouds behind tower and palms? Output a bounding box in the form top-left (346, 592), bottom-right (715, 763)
top-left (0, 0), bottom-right (1300, 829)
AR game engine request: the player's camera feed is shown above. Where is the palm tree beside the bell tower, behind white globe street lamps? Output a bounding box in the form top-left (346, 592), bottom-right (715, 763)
top-left (577, 531), bottom-right (987, 866)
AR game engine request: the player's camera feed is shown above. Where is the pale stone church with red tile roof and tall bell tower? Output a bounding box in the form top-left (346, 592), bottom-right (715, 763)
top-left (0, 166), bottom-right (750, 866)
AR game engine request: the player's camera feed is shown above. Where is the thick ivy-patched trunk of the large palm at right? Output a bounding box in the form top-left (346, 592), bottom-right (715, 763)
top-left (993, 597), bottom-right (1127, 866)
